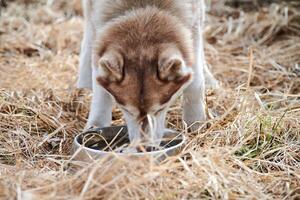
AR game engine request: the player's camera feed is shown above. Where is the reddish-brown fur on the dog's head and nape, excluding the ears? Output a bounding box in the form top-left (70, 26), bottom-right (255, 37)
top-left (96, 5), bottom-right (194, 118)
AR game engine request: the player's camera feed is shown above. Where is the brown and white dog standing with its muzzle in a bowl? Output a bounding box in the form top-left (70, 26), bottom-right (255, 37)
top-left (78, 0), bottom-right (217, 144)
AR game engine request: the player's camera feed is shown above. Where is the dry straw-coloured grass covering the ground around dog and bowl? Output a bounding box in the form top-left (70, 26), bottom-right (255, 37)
top-left (0, 1), bottom-right (300, 199)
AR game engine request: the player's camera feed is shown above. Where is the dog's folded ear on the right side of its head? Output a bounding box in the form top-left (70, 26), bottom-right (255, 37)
top-left (158, 45), bottom-right (192, 82)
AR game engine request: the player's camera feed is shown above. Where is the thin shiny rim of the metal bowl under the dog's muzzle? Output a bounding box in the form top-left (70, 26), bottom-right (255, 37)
top-left (73, 126), bottom-right (186, 156)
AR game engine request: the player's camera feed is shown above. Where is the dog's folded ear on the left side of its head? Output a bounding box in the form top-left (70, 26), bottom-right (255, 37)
top-left (98, 50), bottom-right (124, 82)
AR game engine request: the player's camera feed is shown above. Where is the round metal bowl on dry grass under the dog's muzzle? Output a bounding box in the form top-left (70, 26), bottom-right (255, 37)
top-left (73, 126), bottom-right (185, 161)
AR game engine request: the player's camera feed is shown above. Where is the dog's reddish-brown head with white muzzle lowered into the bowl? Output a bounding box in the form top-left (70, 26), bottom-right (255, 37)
top-left (94, 7), bottom-right (193, 145)
